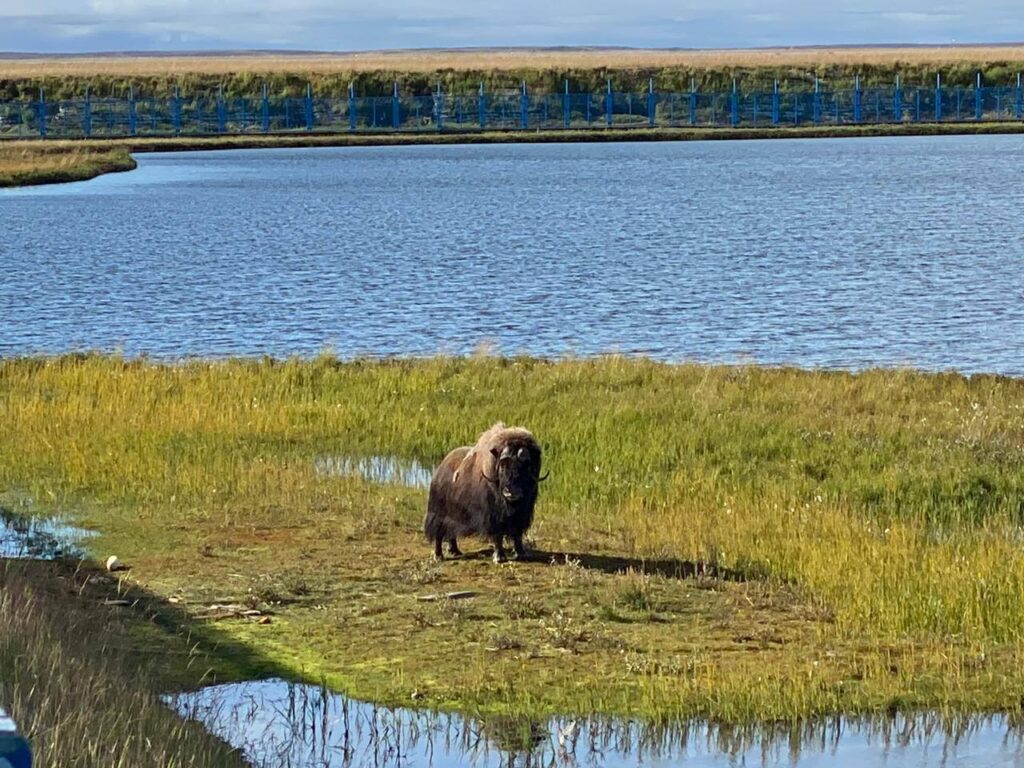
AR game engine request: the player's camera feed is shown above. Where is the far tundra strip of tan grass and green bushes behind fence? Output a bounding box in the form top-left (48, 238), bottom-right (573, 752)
top-left (6, 45), bottom-right (1024, 100)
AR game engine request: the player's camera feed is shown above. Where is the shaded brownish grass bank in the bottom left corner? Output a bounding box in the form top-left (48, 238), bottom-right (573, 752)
top-left (0, 560), bottom-right (243, 768)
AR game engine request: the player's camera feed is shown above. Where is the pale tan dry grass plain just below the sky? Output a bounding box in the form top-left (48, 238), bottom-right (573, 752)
top-left (6, 45), bottom-right (1024, 78)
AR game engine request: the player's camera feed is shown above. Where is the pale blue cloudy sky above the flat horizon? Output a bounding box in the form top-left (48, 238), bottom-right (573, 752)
top-left (0, 0), bottom-right (1024, 52)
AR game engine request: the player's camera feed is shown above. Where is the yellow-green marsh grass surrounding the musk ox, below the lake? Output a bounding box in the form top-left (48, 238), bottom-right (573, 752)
top-left (0, 355), bottom-right (1024, 722)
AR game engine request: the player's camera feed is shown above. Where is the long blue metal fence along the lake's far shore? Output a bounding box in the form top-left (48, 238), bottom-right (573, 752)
top-left (0, 76), bottom-right (1024, 138)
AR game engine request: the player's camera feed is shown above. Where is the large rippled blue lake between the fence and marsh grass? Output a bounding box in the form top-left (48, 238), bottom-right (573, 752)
top-left (0, 136), bottom-right (1024, 375)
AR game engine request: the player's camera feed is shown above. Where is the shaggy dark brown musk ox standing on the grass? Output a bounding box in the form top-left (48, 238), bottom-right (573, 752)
top-left (423, 422), bottom-right (547, 562)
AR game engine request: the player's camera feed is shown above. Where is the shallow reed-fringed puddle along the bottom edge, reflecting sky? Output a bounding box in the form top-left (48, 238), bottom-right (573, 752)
top-left (167, 680), bottom-right (1024, 768)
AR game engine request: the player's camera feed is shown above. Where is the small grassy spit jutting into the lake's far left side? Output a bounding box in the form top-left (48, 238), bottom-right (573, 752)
top-left (0, 141), bottom-right (135, 187)
